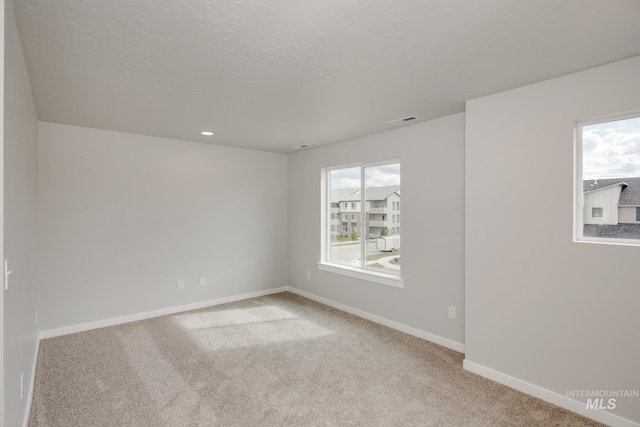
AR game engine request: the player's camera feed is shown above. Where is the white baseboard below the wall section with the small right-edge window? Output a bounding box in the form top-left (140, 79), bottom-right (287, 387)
top-left (462, 359), bottom-right (640, 427)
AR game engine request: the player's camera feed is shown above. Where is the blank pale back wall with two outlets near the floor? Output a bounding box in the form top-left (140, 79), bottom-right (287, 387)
top-left (39, 123), bottom-right (288, 330)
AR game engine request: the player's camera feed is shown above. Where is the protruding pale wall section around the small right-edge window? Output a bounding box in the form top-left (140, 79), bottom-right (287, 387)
top-left (465, 57), bottom-right (640, 422)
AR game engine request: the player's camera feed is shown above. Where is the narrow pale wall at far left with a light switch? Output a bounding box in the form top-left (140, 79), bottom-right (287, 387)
top-left (0, 1), bottom-right (38, 426)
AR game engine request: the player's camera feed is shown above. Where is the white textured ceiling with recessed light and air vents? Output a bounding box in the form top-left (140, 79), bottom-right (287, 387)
top-left (13, 0), bottom-right (640, 152)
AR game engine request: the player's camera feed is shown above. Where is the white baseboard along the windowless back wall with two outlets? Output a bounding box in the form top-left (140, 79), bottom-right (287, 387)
top-left (40, 286), bottom-right (289, 339)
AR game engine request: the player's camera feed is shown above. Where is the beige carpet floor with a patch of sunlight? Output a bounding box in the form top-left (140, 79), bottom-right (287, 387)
top-left (29, 293), bottom-right (599, 427)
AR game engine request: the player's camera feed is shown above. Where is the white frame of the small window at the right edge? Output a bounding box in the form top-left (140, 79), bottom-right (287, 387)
top-left (573, 110), bottom-right (640, 246)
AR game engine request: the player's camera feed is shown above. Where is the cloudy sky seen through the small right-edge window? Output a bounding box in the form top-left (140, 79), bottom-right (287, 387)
top-left (582, 117), bottom-right (640, 179)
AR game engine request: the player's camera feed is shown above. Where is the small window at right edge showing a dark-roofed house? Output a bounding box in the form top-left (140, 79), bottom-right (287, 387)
top-left (575, 112), bottom-right (640, 244)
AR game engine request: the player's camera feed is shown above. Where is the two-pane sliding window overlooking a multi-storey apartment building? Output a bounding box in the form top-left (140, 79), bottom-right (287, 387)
top-left (320, 160), bottom-right (401, 286)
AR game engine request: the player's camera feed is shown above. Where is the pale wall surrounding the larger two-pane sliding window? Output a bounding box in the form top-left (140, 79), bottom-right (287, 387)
top-left (289, 114), bottom-right (464, 345)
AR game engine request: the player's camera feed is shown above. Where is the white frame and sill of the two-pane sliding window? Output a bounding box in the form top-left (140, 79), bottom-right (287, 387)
top-left (318, 158), bottom-right (404, 288)
